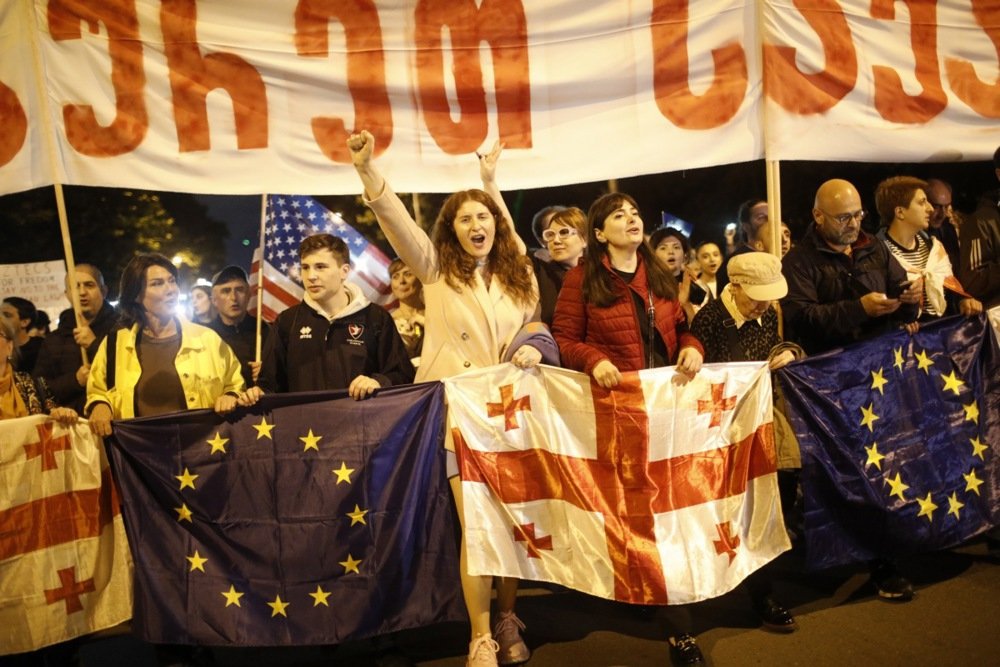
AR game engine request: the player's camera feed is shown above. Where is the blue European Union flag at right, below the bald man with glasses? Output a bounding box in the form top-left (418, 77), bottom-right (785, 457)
top-left (778, 317), bottom-right (1000, 569)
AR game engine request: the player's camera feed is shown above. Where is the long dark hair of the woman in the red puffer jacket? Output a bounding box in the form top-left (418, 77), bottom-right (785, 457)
top-left (583, 192), bottom-right (677, 308)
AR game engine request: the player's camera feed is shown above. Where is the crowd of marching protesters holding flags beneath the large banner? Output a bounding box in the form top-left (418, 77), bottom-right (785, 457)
top-left (0, 146), bottom-right (1000, 665)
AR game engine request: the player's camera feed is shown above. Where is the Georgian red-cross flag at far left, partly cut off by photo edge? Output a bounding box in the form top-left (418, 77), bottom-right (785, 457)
top-left (0, 415), bottom-right (132, 655)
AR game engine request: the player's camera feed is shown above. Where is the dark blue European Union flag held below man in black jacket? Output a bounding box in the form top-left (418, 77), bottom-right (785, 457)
top-left (111, 383), bottom-right (464, 646)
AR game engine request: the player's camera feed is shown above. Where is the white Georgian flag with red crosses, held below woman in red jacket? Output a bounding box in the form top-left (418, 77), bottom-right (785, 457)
top-left (445, 363), bottom-right (790, 604)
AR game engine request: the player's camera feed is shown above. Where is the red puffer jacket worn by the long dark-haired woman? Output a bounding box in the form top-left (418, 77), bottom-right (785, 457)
top-left (552, 256), bottom-right (704, 374)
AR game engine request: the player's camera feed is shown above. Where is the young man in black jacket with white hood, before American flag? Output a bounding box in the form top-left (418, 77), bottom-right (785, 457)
top-left (258, 234), bottom-right (414, 400)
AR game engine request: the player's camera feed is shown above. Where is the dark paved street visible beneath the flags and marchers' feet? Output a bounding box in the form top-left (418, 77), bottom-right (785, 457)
top-left (56, 542), bottom-right (1000, 667)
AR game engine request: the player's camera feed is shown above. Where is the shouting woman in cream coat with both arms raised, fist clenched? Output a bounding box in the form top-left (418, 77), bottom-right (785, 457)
top-left (347, 131), bottom-right (542, 665)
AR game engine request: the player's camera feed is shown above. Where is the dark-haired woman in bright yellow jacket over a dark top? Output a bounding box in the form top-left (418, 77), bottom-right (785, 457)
top-left (84, 253), bottom-right (243, 436)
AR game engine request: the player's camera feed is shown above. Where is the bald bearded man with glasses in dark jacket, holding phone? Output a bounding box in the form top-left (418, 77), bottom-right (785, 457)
top-left (781, 179), bottom-right (923, 354)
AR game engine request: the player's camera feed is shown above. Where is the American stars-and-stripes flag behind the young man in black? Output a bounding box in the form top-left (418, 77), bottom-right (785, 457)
top-left (250, 195), bottom-right (393, 322)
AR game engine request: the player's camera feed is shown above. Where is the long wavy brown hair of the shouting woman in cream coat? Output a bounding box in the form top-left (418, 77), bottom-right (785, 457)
top-left (431, 190), bottom-right (538, 307)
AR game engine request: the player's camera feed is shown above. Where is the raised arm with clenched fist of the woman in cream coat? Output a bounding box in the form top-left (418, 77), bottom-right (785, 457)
top-left (347, 130), bottom-right (437, 285)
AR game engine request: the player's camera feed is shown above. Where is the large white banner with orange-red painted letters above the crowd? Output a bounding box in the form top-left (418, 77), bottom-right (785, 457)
top-left (0, 0), bottom-right (1000, 194)
